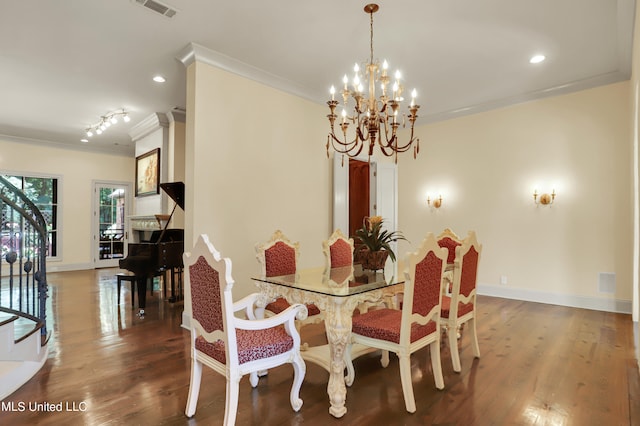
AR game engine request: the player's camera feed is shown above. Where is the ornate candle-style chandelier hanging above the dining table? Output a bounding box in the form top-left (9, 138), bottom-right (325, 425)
top-left (326, 4), bottom-right (420, 164)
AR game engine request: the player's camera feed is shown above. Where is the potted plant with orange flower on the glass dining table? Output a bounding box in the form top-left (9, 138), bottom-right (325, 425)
top-left (354, 216), bottom-right (406, 270)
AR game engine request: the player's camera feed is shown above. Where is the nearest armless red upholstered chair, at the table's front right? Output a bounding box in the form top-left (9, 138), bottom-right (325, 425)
top-left (345, 233), bottom-right (447, 413)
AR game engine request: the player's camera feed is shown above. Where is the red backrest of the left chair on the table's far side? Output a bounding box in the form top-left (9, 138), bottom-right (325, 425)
top-left (256, 230), bottom-right (300, 277)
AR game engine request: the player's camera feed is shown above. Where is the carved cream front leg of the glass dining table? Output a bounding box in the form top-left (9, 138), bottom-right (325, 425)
top-left (324, 297), bottom-right (351, 417)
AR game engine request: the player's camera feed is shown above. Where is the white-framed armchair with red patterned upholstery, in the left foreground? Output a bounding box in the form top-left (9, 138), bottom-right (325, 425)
top-left (183, 235), bottom-right (307, 425)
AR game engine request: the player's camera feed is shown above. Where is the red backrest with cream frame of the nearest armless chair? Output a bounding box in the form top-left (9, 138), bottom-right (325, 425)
top-left (400, 233), bottom-right (447, 341)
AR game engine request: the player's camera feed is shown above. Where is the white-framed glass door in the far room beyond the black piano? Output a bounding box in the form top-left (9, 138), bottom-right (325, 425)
top-left (92, 182), bottom-right (131, 268)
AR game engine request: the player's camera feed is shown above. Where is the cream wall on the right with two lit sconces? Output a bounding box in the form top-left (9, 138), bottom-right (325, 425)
top-left (399, 82), bottom-right (633, 312)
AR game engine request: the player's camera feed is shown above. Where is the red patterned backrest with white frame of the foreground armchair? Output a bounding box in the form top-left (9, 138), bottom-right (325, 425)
top-left (183, 234), bottom-right (238, 365)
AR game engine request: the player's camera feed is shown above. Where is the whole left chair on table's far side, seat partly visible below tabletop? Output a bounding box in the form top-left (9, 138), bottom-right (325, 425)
top-left (256, 230), bottom-right (324, 322)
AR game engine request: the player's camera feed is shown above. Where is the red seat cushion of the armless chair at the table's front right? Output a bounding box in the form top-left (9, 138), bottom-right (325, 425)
top-left (352, 309), bottom-right (436, 343)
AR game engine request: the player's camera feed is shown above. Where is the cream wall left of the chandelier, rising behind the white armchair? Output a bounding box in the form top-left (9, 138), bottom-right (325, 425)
top-left (185, 62), bottom-right (331, 302)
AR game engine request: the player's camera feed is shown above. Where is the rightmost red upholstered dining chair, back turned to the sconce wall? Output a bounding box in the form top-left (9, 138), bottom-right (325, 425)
top-left (441, 231), bottom-right (482, 373)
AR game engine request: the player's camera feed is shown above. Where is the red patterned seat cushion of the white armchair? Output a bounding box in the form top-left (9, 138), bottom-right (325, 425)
top-left (196, 327), bottom-right (293, 364)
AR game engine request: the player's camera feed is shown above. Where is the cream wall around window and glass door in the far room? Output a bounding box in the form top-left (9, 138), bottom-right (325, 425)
top-left (0, 138), bottom-right (134, 271)
